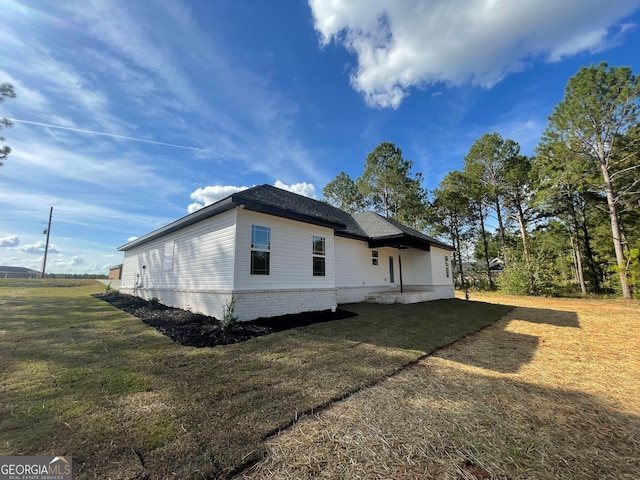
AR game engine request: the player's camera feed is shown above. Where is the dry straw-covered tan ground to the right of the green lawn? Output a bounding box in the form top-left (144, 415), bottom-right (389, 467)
top-left (239, 295), bottom-right (640, 480)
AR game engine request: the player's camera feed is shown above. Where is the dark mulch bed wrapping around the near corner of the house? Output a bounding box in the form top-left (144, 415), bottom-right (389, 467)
top-left (94, 293), bottom-right (357, 347)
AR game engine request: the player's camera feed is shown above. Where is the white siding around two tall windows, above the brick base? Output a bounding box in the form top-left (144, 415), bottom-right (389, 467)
top-left (234, 210), bottom-right (334, 291)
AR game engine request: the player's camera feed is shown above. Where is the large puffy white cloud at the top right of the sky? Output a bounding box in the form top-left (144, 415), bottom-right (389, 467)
top-left (309, 0), bottom-right (640, 108)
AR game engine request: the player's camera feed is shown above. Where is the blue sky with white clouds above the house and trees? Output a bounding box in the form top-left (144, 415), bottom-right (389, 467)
top-left (0, 0), bottom-right (640, 273)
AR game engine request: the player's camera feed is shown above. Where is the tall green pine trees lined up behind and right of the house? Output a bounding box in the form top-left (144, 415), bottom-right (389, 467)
top-left (323, 63), bottom-right (640, 298)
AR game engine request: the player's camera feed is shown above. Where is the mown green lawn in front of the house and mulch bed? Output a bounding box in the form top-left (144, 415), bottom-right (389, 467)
top-left (0, 280), bottom-right (509, 479)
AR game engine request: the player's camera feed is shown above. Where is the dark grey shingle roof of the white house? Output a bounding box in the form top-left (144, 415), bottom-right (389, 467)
top-left (118, 185), bottom-right (452, 250)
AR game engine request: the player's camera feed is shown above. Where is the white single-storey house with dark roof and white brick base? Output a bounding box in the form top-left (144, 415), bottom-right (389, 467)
top-left (118, 185), bottom-right (454, 320)
